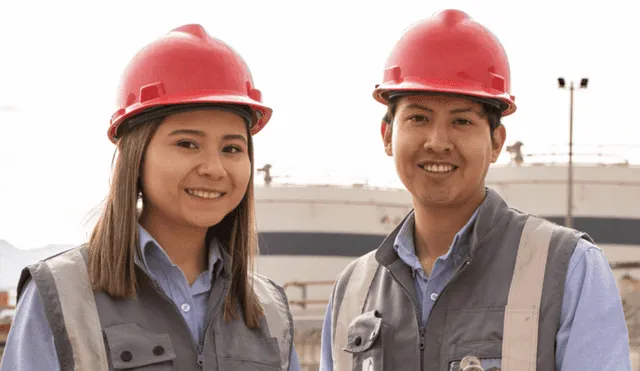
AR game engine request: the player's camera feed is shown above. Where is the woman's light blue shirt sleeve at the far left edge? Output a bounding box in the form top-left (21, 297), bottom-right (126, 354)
top-left (0, 280), bottom-right (60, 371)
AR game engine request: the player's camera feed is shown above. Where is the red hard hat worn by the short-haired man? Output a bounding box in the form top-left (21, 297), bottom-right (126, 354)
top-left (373, 10), bottom-right (516, 116)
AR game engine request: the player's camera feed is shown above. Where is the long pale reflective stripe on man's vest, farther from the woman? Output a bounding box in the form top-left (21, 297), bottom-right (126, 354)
top-left (502, 216), bottom-right (557, 371)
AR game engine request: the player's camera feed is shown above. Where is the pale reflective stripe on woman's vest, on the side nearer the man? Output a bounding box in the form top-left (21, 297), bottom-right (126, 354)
top-left (253, 274), bottom-right (293, 371)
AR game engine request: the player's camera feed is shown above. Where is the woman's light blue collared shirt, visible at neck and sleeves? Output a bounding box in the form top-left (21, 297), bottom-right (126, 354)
top-left (0, 226), bottom-right (301, 371)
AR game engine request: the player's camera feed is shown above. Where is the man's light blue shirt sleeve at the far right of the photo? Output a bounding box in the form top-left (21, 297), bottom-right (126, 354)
top-left (556, 239), bottom-right (631, 371)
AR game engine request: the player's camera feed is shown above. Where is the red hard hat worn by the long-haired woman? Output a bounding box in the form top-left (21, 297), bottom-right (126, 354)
top-left (108, 24), bottom-right (272, 143)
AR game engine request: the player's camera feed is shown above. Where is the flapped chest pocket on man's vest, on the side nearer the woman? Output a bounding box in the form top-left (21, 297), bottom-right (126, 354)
top-left (343, 310), bottom-right (391, 371)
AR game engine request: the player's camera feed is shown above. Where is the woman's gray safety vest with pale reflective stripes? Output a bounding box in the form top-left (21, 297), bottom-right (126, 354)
top-left (18, 246), bottom-right (293, 371)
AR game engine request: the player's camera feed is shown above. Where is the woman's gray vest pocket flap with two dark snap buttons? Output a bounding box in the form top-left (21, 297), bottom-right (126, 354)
top-left (104, 323), bottom-right (176, 371)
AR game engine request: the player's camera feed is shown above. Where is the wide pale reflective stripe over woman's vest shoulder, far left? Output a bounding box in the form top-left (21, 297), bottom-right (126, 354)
top-left (29, 247), bottom-right (109, 371)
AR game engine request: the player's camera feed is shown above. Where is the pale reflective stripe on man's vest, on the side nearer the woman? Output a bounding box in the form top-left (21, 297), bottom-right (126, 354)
top-left (331, 250), bottom-right (379, 371)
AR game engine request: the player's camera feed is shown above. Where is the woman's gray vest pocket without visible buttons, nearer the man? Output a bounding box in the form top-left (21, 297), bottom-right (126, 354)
top-left (215, 335), bottom-right (281, 371)
